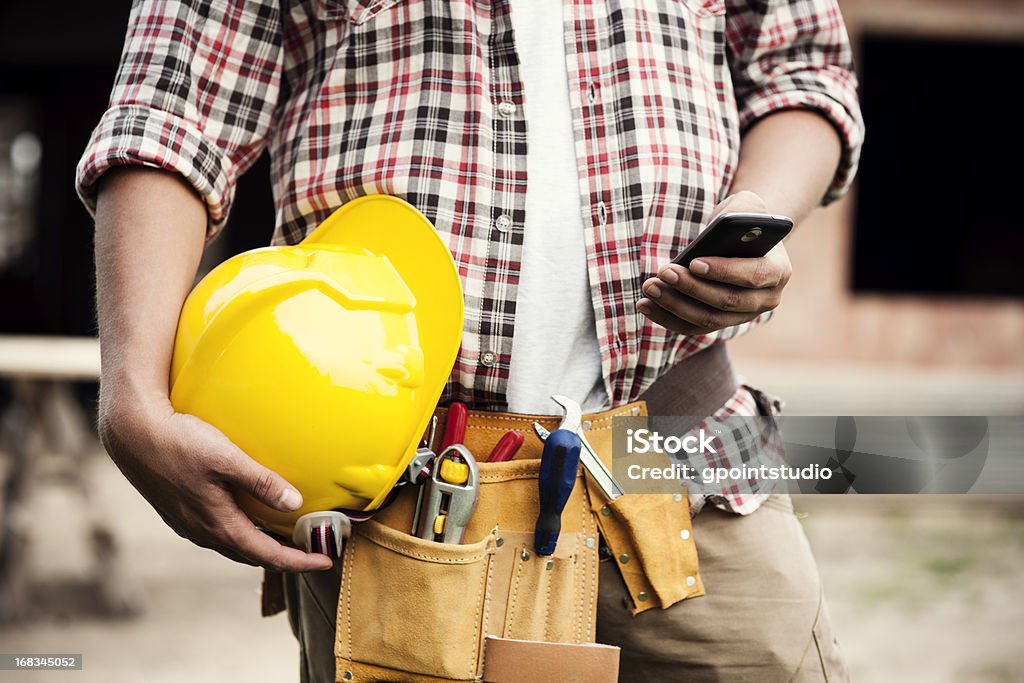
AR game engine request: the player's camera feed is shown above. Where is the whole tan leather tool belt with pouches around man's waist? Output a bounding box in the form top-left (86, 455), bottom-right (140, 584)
top-left (264, 345), bottom-right (737, 681)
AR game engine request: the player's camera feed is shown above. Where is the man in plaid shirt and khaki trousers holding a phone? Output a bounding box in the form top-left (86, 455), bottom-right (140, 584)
top-left (78, 0), bottom-right (862, 681)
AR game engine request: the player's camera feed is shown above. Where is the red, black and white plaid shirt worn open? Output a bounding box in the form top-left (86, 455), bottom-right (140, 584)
top-left (78, 0), bottom-right (862, 511)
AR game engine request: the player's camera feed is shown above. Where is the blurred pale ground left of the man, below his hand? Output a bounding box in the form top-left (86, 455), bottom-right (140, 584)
top-left (0, 450), bottom-right (298, 683)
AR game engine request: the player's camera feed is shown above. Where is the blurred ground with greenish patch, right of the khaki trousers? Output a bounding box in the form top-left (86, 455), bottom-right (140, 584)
top-left (796, 496), bottom-right (1024, 683)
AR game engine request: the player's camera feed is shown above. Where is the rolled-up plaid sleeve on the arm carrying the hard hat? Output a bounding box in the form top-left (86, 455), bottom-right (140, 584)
top-left (76, 0), bottom-right (282, 236)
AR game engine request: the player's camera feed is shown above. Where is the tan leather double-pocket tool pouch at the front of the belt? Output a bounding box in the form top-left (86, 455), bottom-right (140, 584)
top-left (335, 458), bottom-right (617, 682)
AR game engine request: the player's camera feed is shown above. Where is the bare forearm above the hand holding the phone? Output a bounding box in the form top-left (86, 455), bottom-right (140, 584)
top-left (730, 110), bottom-right (842, 225)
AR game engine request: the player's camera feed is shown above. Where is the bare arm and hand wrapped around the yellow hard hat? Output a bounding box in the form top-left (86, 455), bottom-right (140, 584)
top-left (96, 167), bottom-right (332, 571)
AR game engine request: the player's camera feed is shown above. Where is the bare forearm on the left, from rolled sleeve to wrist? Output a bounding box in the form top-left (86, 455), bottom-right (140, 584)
top-left (96, 167), bottom-right (207, 408)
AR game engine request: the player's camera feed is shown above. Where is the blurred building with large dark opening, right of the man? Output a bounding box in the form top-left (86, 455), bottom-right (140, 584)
top-left (731, 0), bottom-right (1024, 415)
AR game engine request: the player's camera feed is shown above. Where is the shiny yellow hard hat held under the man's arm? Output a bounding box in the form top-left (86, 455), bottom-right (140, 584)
top-left (170, 195), bottom-right (463, 533)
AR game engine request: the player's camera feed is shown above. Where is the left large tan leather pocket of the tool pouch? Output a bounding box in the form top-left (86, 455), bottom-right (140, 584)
top-left (335, 520), bottom-right (496, 681)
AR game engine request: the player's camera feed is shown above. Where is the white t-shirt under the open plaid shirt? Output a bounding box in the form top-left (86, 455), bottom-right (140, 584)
top-left (508, 0), bottom-right (608, 415)
